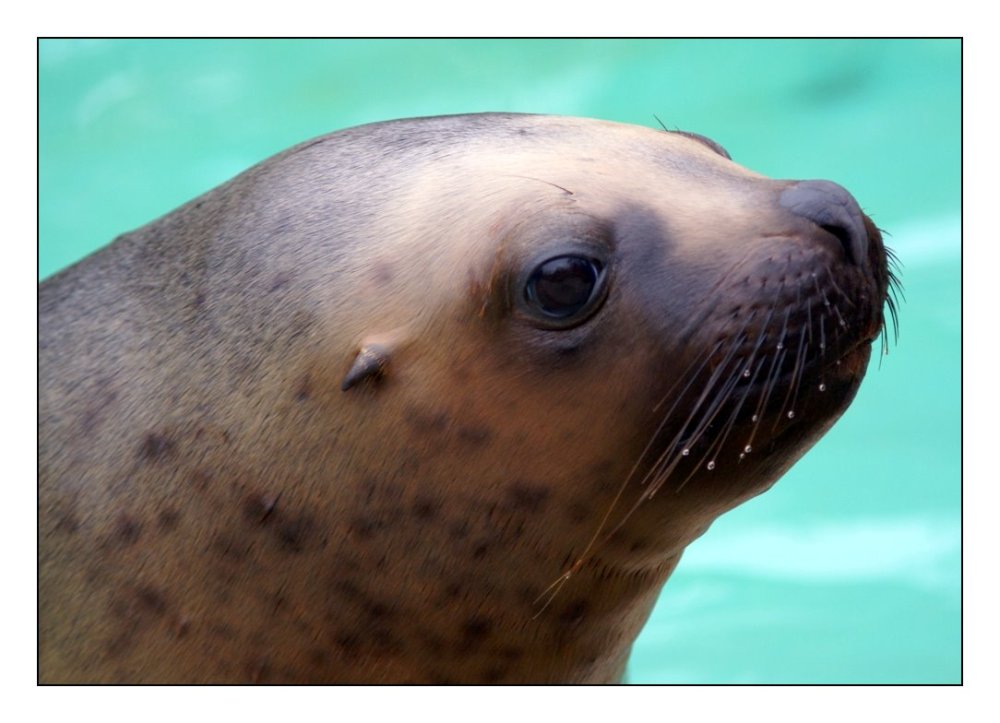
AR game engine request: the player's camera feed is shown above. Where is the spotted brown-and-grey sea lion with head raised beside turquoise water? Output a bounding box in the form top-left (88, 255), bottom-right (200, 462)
top-left (39, 114), bottom-right (892, 683)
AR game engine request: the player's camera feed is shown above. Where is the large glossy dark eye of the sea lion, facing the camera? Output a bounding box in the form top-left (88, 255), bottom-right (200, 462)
top-left (524, 255), bottom-right (604, 326)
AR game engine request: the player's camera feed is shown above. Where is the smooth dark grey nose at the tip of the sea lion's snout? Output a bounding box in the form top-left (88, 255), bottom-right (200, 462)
top-left (778, 181), bottom-right (868, 265)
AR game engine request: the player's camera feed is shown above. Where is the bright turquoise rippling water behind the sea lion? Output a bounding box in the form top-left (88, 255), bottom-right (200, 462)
top-left (39, 40), bottom-right (961, 683)
